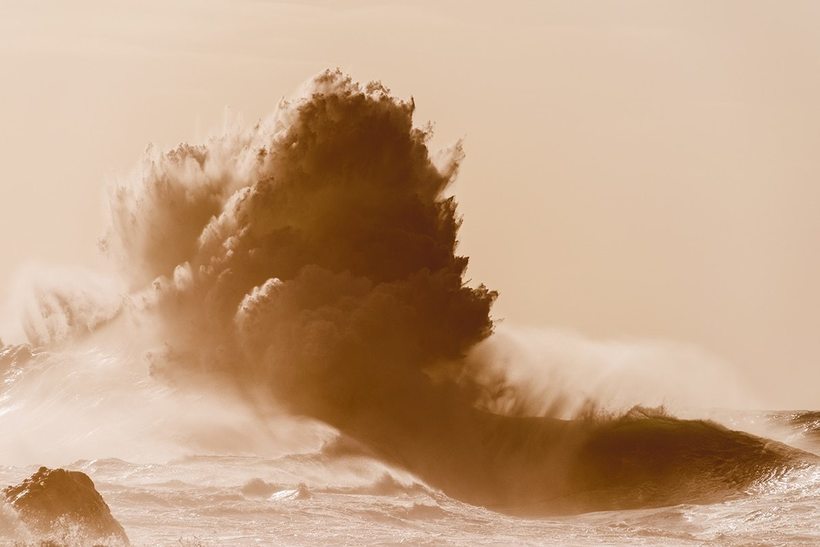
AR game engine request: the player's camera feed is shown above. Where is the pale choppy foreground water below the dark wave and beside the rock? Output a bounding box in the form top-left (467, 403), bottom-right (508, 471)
top-left (0, 413), bottom-right (820, 545)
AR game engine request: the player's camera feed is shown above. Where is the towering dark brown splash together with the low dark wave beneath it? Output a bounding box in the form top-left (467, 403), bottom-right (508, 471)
top-left (8, 70), bottom-right (812, 513)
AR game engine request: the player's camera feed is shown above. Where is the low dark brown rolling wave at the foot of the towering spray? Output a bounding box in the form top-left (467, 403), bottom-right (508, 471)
top-left (340, 402), bottom-right (818, 515)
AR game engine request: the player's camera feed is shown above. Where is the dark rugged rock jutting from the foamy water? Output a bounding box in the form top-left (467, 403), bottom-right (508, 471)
top-left (3, 467), bottom-right (129, 545)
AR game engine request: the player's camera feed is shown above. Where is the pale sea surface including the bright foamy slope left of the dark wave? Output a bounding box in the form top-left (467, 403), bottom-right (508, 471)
top-left (0, 350), bottom-right (820, 545)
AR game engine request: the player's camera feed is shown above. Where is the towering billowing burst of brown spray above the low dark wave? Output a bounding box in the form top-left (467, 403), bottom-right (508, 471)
top-left (105, 72), bottom-right (495, 415)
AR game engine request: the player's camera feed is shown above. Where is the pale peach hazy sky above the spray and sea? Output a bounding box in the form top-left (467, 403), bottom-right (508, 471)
top-left (0, 0), bottom-right (820, 408)
